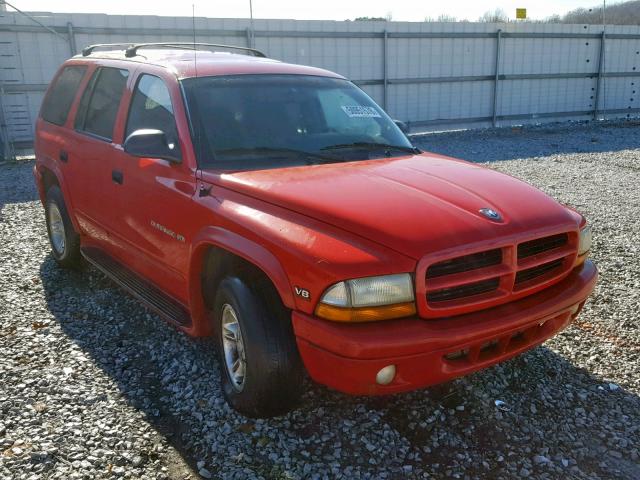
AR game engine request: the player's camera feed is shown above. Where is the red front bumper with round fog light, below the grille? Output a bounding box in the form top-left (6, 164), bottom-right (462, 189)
top-left (292, 260), bottom-right (597, 395)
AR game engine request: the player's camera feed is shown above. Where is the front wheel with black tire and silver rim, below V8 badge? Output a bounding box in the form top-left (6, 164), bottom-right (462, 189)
top-left (214, 277), bottom-right (303, 418)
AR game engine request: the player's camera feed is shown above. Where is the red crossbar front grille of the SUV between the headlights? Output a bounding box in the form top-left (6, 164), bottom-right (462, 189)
top-left (417, 231), bottom-right (578, 318)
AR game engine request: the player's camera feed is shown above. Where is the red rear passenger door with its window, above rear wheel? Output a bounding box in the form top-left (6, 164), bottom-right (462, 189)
top-left (68, 66), bottom-right (129, 243)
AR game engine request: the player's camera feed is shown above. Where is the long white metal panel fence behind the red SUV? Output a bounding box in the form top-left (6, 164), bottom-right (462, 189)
top-left (0, 12), bottom-right (640, 155)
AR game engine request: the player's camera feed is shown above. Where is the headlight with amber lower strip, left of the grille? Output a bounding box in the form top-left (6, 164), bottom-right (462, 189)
top-left (316, 273), bottom-right (416, 322)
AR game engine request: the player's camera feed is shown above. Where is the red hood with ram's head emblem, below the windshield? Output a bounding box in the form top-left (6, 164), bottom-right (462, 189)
top-left (205, 153), bottom-right (579, 259)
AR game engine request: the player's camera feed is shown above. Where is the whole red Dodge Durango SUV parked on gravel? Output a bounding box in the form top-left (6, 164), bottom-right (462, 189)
top-left (34, 43), bottom-right (597, 416)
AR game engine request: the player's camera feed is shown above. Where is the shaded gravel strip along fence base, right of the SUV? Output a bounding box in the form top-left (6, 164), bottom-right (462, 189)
top-left (411, 120), bottom-right (640, 162)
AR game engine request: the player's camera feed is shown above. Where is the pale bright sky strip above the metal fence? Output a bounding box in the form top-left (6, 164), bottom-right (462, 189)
top-left (2, 0), bottom-right (617, 22)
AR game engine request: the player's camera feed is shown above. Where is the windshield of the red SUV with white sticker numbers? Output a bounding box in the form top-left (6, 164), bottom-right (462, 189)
top-left (183, 74), bottom-right (414, 170)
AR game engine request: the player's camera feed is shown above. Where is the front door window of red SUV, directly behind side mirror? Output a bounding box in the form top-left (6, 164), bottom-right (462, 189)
top-left (125, 75), bottom-right (178, 143)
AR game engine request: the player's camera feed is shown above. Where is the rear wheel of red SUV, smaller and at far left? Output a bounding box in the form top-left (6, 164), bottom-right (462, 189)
top-left (45, 185), bottom-right (81, 269)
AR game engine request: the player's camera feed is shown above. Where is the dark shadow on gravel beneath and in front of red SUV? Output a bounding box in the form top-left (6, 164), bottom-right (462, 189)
top-left (40, 255), bottom-right (640, 479)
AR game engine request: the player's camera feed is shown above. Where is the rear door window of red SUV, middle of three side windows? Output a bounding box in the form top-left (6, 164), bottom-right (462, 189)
top-left (75, 67), bottom-right (129, 141)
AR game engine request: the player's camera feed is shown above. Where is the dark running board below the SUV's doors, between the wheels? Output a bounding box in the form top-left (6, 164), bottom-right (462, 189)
top-left (81, 247), bottom-right (191, 327)
